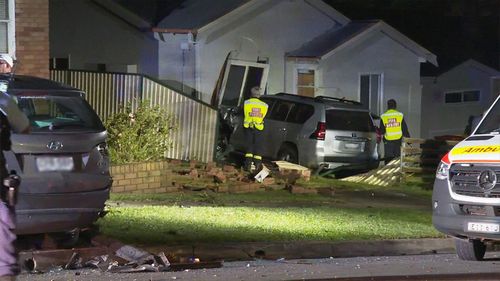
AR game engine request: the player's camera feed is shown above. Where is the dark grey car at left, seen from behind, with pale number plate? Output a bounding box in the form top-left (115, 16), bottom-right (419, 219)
top-left (0, 75), bottom-right (112, 234)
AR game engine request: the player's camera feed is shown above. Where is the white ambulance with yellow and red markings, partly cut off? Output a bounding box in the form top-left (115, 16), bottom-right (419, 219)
top-left (432, 93), bottom-right (500, 260)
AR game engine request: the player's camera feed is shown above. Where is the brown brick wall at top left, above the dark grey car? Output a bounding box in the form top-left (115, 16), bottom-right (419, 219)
top-left (16, 0), bottom-right (49, 78)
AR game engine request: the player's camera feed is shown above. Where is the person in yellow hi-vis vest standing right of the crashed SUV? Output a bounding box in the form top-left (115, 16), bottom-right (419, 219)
top-left (380, 99), bottom-right (410, 164)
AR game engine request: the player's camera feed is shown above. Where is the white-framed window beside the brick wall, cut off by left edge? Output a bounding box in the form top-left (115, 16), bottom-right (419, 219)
top-left (0, 0), bottom-right (14, 54)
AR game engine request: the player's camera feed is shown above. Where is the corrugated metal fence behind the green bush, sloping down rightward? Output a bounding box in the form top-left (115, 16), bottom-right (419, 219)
top-left (50, 70), bottom-right (217, 162)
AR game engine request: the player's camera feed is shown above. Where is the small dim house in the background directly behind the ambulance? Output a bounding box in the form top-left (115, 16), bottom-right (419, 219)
top-left (421, 59), bottom-right (500, 138)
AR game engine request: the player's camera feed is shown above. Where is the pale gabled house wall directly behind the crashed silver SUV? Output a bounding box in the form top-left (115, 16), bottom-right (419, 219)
top-left (287, 33), bottom-right (421, 137)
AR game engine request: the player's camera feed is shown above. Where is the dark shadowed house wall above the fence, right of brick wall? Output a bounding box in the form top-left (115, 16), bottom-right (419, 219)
top-left (49, 0), bottom-right (158, 77)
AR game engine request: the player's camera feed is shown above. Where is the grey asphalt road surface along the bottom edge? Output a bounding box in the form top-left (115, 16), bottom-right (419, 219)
top-left (17, 252), bottom-right (500, 281)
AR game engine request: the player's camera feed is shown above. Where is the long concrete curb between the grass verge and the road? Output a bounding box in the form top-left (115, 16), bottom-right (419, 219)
top-left (145, 238), bottom-right (455, 261)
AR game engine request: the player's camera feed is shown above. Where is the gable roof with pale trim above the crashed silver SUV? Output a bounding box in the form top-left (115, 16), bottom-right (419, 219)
top-left (287, 20), bottom-right (437, 66)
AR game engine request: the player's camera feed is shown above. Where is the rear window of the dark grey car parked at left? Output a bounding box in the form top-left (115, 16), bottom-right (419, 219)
top-left (16, 94), bottom-right (104, 132)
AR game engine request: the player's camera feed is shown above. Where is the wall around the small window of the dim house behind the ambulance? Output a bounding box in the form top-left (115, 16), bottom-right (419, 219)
top-left (422, 63), bottom-right (496, 138)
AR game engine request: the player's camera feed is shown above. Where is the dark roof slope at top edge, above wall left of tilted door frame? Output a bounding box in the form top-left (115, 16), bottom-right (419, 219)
top-left (155, 0), bottom-right (252, 32)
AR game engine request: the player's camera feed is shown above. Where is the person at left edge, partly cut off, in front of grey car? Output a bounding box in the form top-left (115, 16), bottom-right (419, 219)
top-left (0, 70), bottom-right (29, 281)
